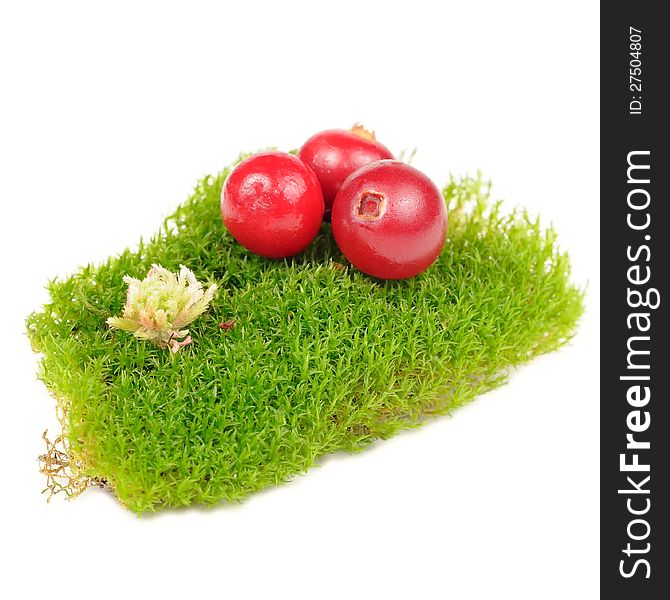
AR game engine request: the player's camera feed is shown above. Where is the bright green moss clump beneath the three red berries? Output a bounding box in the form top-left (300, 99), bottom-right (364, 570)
top-left (28, 159), bottom-right (583, 513)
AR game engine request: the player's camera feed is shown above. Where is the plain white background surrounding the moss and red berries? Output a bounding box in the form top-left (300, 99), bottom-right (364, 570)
top-left (0, 0), bottom-right (599, 600)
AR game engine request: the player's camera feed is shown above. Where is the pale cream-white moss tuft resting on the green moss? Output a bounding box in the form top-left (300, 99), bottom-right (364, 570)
top-left (107, 265), bottom-right (217, 352)
